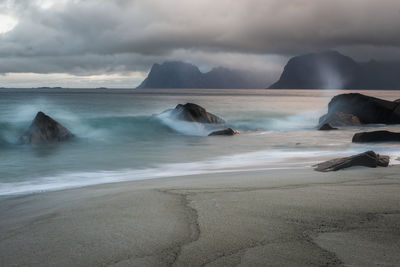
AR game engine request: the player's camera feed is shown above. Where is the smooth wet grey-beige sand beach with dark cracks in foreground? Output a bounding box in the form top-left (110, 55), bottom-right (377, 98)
top-left (0, 167), bottom-right (400, 266)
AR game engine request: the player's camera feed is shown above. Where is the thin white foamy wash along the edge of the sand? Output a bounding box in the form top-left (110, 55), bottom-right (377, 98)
top-left (0, 148), bottom-right (400, 196)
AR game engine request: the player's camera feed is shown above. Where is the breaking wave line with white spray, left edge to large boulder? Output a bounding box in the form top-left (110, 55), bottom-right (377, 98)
top-left (0, 99), bottom-right (324, 146)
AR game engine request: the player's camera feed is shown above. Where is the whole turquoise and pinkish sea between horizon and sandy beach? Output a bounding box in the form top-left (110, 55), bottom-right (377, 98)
top-left (0, 89), bottom-right (400, 197)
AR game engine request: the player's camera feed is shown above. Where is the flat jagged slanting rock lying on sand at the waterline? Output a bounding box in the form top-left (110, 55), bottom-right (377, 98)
top-left (314, 151), bottom-right (390, 172)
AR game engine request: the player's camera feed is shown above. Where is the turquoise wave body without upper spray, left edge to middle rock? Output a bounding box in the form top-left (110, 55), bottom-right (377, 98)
top-left (0, 114), bottom-right (231, 145)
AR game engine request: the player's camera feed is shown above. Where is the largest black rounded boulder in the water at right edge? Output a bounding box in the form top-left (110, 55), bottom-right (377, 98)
top-left (319, 93), bottom-right (400, 126)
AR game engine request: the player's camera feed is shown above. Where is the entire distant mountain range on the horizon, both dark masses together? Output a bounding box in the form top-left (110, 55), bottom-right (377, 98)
top-left (138, 51), bottom-right (400, 90)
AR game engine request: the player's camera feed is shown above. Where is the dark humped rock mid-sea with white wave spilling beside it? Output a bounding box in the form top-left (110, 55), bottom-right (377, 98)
top-left (171, 103), bottom-right (225, 124)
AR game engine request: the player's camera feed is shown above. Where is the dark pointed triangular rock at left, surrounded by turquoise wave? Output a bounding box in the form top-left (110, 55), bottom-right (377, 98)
top-left (20, 111), bottom-right (74, 144)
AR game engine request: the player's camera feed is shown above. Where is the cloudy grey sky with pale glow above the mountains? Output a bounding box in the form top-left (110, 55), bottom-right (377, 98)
top-left (0, 0), bottom-right (400, 88)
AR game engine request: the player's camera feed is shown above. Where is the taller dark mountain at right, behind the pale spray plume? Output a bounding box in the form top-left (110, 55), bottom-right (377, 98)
top-left (269, 51), bottom-right (400, 89)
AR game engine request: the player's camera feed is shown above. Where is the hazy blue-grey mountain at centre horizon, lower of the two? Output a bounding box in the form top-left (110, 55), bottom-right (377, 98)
top-left (138, 61), bottom-right (268, 89)
